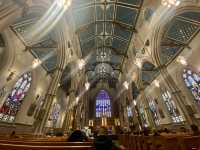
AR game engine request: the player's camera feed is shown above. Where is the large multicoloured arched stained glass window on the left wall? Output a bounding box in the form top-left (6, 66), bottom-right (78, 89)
top-left (0, 72), bottom-right (32, 122)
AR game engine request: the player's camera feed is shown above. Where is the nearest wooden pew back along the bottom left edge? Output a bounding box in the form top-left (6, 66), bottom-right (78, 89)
top-left (0, 143), bottom-right (93, 150)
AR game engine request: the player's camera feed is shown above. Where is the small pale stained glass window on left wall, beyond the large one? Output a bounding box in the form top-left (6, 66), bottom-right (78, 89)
top-left (49, 103), bottom-right (61, 122)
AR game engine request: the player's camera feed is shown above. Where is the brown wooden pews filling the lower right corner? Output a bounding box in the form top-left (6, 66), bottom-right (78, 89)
top-left (119, 135), bottom-right (200, 150)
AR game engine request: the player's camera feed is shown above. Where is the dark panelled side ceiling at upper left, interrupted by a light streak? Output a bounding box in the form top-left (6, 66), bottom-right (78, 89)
top-left (11, 9), bottom-right (57, 73)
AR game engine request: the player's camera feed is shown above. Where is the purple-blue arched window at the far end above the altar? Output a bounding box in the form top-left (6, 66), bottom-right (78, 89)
top-left (96, 90), bottom-right (111, 118)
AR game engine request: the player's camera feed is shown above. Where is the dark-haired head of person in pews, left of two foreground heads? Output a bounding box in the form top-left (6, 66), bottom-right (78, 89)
top-left (67, 130), bottom-right (88, 142)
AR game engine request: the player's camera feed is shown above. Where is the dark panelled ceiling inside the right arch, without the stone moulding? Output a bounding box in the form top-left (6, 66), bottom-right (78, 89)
top-left (160, 11), bottom-right (200, 64)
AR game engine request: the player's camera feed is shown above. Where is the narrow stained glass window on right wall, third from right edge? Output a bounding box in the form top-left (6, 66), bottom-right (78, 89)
top-left (149, 100), bottom-right (160, 125)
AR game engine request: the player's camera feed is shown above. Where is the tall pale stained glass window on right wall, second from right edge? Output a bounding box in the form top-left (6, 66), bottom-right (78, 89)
top-left (162, 91), bottom-right (183, 123)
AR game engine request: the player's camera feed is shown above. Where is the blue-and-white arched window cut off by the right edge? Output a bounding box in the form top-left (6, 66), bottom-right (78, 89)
top-left (183, 69), bottom-right (200, 104)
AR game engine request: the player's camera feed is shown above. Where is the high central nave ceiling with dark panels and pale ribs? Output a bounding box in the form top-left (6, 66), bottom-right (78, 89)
top-left (72, 0), bottom-right (142, 86)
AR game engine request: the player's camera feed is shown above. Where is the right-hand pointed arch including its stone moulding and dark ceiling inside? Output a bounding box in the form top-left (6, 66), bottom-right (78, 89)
top-left (152, 6), bottom-right (200, 66)
